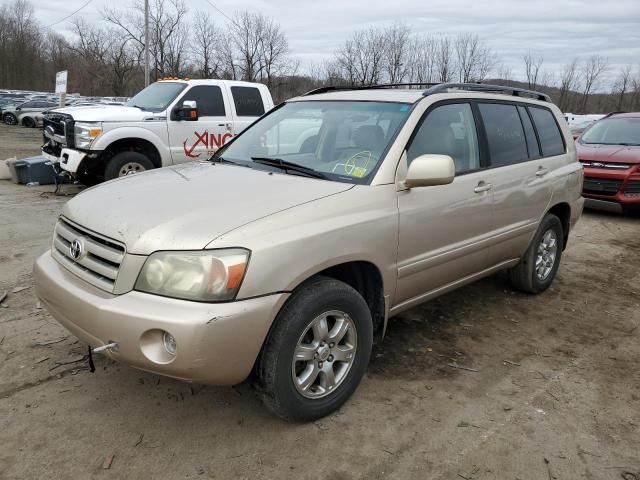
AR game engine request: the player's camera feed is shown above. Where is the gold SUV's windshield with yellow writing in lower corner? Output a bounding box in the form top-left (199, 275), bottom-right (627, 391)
top-left (216, 101), bottom-right (411, 183)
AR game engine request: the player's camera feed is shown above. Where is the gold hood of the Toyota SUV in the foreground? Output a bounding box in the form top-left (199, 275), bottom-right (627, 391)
top-left (62, 162), bottom-right (353, 255)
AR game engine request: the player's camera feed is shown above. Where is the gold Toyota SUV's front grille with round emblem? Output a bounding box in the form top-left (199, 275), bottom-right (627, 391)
top-left (51, 218), bottom-right (125, 292)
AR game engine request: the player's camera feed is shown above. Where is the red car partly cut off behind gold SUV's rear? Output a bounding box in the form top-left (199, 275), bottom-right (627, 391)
top-left (576, 112), bottom-right (640, 213)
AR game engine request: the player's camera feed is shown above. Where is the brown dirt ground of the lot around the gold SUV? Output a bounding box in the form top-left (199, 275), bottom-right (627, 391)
top-left (0, 122), bottom-right (640, 480)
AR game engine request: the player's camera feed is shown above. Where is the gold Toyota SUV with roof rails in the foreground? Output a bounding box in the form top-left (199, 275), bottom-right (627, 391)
top-left (34, 84), bottom-right (583, 420)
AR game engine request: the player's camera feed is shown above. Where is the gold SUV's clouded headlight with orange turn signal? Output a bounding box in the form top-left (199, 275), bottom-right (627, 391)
top-left (135, 248), bottom-right (249, 302)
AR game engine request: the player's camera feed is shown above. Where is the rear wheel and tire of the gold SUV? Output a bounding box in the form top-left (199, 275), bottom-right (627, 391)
top-left (509, 214), bottom-right (564, 294)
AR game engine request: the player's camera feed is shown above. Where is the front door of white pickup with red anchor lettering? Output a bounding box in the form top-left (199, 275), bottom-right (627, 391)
top-left (167, 85), bottom-right (233, 163)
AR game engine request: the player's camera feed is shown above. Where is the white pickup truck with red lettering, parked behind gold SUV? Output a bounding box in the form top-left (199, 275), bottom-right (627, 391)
top-left (42, 79), bottom-right (273, 185)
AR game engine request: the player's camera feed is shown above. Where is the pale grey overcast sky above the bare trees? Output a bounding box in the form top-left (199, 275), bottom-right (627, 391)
top-left (25, 0), bottom-right (640, 88)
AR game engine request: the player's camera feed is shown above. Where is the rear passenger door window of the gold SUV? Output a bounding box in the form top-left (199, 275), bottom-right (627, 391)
top-left (478, 103), bottom-right (529, 167)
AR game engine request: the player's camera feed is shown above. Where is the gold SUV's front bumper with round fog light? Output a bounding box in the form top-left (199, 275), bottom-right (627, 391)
top-left (34, 251), bottom-right (288, 385)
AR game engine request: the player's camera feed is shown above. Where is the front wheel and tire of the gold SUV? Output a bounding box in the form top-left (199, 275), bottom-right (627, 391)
top-left (254, 277), bottom-right (373, 421)
